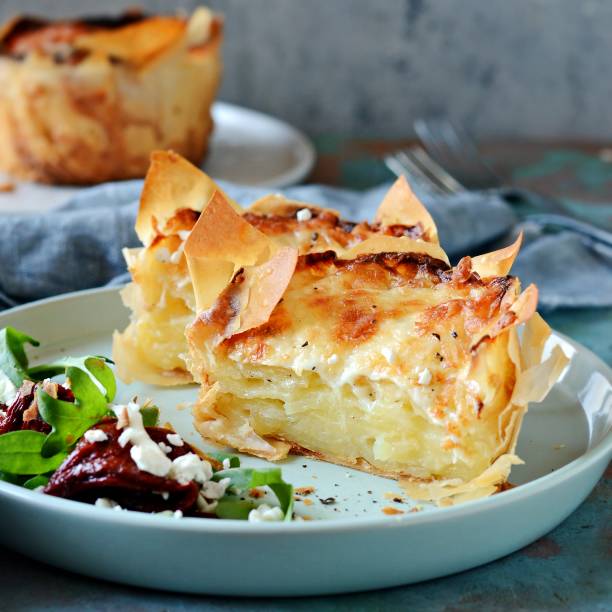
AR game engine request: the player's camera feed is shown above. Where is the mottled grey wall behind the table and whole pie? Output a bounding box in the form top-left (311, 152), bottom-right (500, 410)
top-left (0, 0), bottom-right (612, 140)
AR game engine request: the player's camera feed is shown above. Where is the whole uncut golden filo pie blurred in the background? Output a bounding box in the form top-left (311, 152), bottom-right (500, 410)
top-left (0, 8), bottom-right (223, 184)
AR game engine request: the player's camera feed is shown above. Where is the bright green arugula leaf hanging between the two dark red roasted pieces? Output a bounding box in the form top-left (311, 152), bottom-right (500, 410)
top-left (37, 366), bottom-right (108, 457)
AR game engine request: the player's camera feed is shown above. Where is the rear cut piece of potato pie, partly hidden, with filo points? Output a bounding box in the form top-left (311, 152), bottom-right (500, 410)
top-left (113, 151), bottom-right (445, 385)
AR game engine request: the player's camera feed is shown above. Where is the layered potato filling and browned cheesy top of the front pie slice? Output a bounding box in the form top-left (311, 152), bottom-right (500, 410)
top-left (189, 253), bottom-right (519, 486)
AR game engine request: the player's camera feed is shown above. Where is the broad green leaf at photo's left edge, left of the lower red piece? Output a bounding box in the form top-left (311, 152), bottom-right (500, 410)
top-left (0, 429), bottom-right (66, 475)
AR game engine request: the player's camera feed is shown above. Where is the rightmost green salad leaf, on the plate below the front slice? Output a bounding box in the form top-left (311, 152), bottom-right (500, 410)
top-left (213, 468), bottom-right (293, 521)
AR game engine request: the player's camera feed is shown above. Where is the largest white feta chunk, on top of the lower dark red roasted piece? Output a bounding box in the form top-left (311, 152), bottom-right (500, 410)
top-left (113, 402), bottom-right (172, 476)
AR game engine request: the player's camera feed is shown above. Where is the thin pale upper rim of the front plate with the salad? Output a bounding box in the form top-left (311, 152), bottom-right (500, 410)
top-left (0, 286), bottom-right (612, 535)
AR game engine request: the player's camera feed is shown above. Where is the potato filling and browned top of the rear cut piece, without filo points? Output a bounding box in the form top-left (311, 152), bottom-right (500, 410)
top-left (113, 202), bottom-right (423, 385)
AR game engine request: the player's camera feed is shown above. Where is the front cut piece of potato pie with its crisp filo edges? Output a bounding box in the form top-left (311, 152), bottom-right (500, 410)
top-left (185, 190), bottom-right (567, 503)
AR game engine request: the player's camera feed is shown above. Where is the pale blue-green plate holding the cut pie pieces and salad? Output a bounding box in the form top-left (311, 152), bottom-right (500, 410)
top-left (0, 289), bottom-right (612, 595)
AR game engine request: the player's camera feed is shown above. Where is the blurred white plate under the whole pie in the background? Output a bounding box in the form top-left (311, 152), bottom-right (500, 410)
top-left (0, 102), bottom-right (316, 218)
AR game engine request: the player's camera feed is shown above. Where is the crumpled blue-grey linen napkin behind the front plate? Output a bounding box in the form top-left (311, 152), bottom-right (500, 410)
top-left (0, 181), bottom-right (612, 310)
